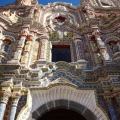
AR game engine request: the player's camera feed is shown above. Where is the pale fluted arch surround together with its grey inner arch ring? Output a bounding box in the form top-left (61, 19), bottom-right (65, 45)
top-left (29, 85), bottom-right (108, 120)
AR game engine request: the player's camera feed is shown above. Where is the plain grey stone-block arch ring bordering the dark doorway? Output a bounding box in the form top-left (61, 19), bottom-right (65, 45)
top-left (32, 99), bottom-right (97, 120)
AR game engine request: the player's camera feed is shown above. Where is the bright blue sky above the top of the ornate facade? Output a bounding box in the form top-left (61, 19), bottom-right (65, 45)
top-left (0, 0), bottom-right (80, 6)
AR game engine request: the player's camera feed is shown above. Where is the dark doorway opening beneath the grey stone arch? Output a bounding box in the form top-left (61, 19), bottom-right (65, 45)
top-left (37, 108), bottom-right (86, 120)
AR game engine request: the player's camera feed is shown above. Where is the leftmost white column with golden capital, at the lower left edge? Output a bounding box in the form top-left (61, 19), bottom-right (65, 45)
top-left (0, 91), bottom-right (11, 120)
